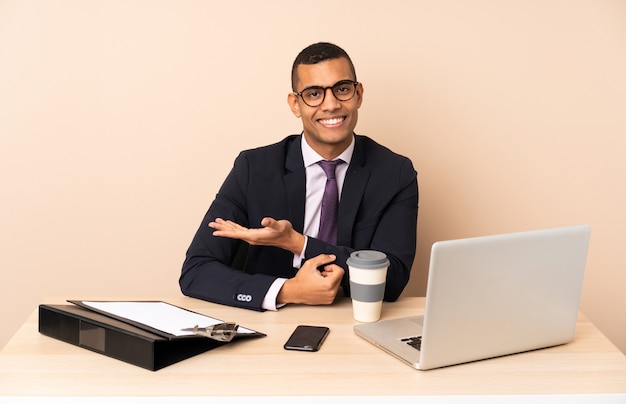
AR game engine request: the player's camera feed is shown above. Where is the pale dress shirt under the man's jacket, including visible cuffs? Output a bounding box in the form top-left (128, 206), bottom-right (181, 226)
top-left (261, 134), bottom-right (354, 310)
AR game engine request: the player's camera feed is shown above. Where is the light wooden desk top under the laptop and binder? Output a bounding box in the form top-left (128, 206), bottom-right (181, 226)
top-left (0, 297), bottom-right (626, 396)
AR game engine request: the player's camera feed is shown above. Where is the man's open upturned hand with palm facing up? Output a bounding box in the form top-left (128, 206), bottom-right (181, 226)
top-left (209, 217), bottom-right (304, 255)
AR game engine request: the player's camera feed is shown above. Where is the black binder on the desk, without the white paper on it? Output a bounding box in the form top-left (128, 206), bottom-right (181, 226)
top-left (39, 304), bottom-right (265, 371)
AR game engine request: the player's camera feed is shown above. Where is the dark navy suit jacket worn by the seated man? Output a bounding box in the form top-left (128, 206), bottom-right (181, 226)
top-left (179, 135), bottom-right (418, 310)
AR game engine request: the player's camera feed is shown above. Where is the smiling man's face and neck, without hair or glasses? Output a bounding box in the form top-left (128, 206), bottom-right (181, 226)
top-left (288, 57), bottom-right (363, 160)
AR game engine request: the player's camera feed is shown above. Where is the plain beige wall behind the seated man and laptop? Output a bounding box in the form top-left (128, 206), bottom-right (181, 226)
top-left (0, 0), bottom-right (626, 351)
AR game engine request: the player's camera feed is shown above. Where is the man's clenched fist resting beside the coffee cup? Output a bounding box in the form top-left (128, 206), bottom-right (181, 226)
top-left (276, 254), bottom-right (345, 305)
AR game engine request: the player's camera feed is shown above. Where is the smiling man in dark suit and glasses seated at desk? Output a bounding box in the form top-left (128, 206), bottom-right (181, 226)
top-left (179, 43), bottom-right (418, 310)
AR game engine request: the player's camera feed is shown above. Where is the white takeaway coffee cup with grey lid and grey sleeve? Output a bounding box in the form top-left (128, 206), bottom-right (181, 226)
top-left (346, 250), bottom-right (389, 323)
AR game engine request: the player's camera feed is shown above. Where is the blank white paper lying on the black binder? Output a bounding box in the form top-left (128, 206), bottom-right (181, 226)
top-left (82, 300), bottom-right (255, 337)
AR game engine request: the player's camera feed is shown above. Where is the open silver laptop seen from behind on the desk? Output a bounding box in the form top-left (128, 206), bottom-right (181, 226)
top-left (354, 225), bottom-right (590, 370)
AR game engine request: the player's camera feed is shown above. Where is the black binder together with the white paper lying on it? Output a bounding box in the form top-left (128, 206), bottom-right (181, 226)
top-left (39, 300), bottom-right (265, 370)
